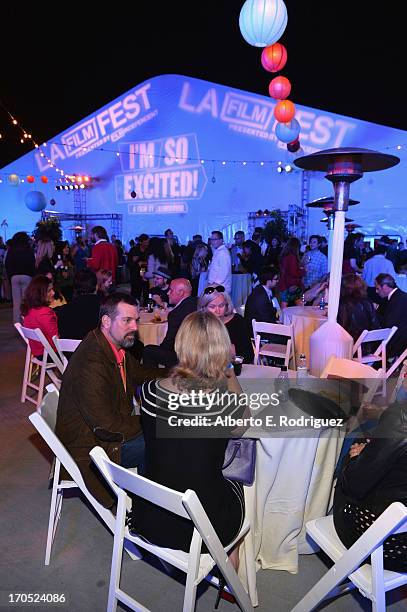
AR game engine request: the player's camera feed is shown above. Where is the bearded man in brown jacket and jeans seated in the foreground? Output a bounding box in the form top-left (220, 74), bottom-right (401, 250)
top-left (56, 293), bottom-right (167, 508)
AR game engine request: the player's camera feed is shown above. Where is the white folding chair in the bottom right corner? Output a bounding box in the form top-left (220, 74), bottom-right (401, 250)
top-left (291, 502), bottom-right (407, 612)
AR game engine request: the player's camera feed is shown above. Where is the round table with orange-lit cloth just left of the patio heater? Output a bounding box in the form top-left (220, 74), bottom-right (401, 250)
top-left (281, 306), bottom-right (327, 366)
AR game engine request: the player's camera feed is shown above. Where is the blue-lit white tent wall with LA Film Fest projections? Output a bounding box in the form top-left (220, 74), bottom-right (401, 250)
top-left (0, 75), bottom-right (407, 242)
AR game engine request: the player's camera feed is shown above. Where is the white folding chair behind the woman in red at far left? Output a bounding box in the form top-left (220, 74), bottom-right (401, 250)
top-left (14, 323), bottom-right (64, 410)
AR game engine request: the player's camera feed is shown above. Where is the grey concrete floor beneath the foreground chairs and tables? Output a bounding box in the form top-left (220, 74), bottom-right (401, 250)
top-left (0, 305), bottom-right (407, 612)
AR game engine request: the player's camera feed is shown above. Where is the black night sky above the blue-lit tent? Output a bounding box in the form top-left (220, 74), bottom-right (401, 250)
top-left (0, 0), bottom-right (407, 167)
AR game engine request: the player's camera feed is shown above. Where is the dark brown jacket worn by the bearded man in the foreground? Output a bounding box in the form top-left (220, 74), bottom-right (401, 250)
top-left (55, 329), bottom-right (167, 508)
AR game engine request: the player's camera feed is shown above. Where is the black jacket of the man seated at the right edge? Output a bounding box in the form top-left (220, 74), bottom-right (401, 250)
top-left (379, 289), bottom-right (407, 357)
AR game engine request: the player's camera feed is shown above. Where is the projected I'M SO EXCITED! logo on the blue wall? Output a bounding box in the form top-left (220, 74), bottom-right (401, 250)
top-left (115, 134), bottom-right (207, 214)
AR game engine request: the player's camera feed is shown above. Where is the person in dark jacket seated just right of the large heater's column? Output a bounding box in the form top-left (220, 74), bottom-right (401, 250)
top-left (338, 274), bottom-right (381, 341)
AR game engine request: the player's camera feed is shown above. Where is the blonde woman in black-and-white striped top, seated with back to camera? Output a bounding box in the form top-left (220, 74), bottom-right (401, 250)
top-left (132, 312), bottom-right (244, 580)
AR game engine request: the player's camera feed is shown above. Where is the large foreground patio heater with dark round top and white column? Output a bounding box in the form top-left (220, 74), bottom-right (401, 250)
top-left (294, 147), bottom-right (400, 376)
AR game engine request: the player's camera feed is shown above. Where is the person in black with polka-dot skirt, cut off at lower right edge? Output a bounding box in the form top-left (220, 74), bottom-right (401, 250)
top-left (333, 396), bottom-right (407, 572)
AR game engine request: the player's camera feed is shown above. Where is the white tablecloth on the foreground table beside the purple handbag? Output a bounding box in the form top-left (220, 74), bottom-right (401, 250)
top-left (239, 364), bottom-right (343, 601)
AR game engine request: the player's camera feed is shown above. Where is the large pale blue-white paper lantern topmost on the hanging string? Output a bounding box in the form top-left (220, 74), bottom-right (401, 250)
top-left (239, 0), bottom-right (288, 47)
